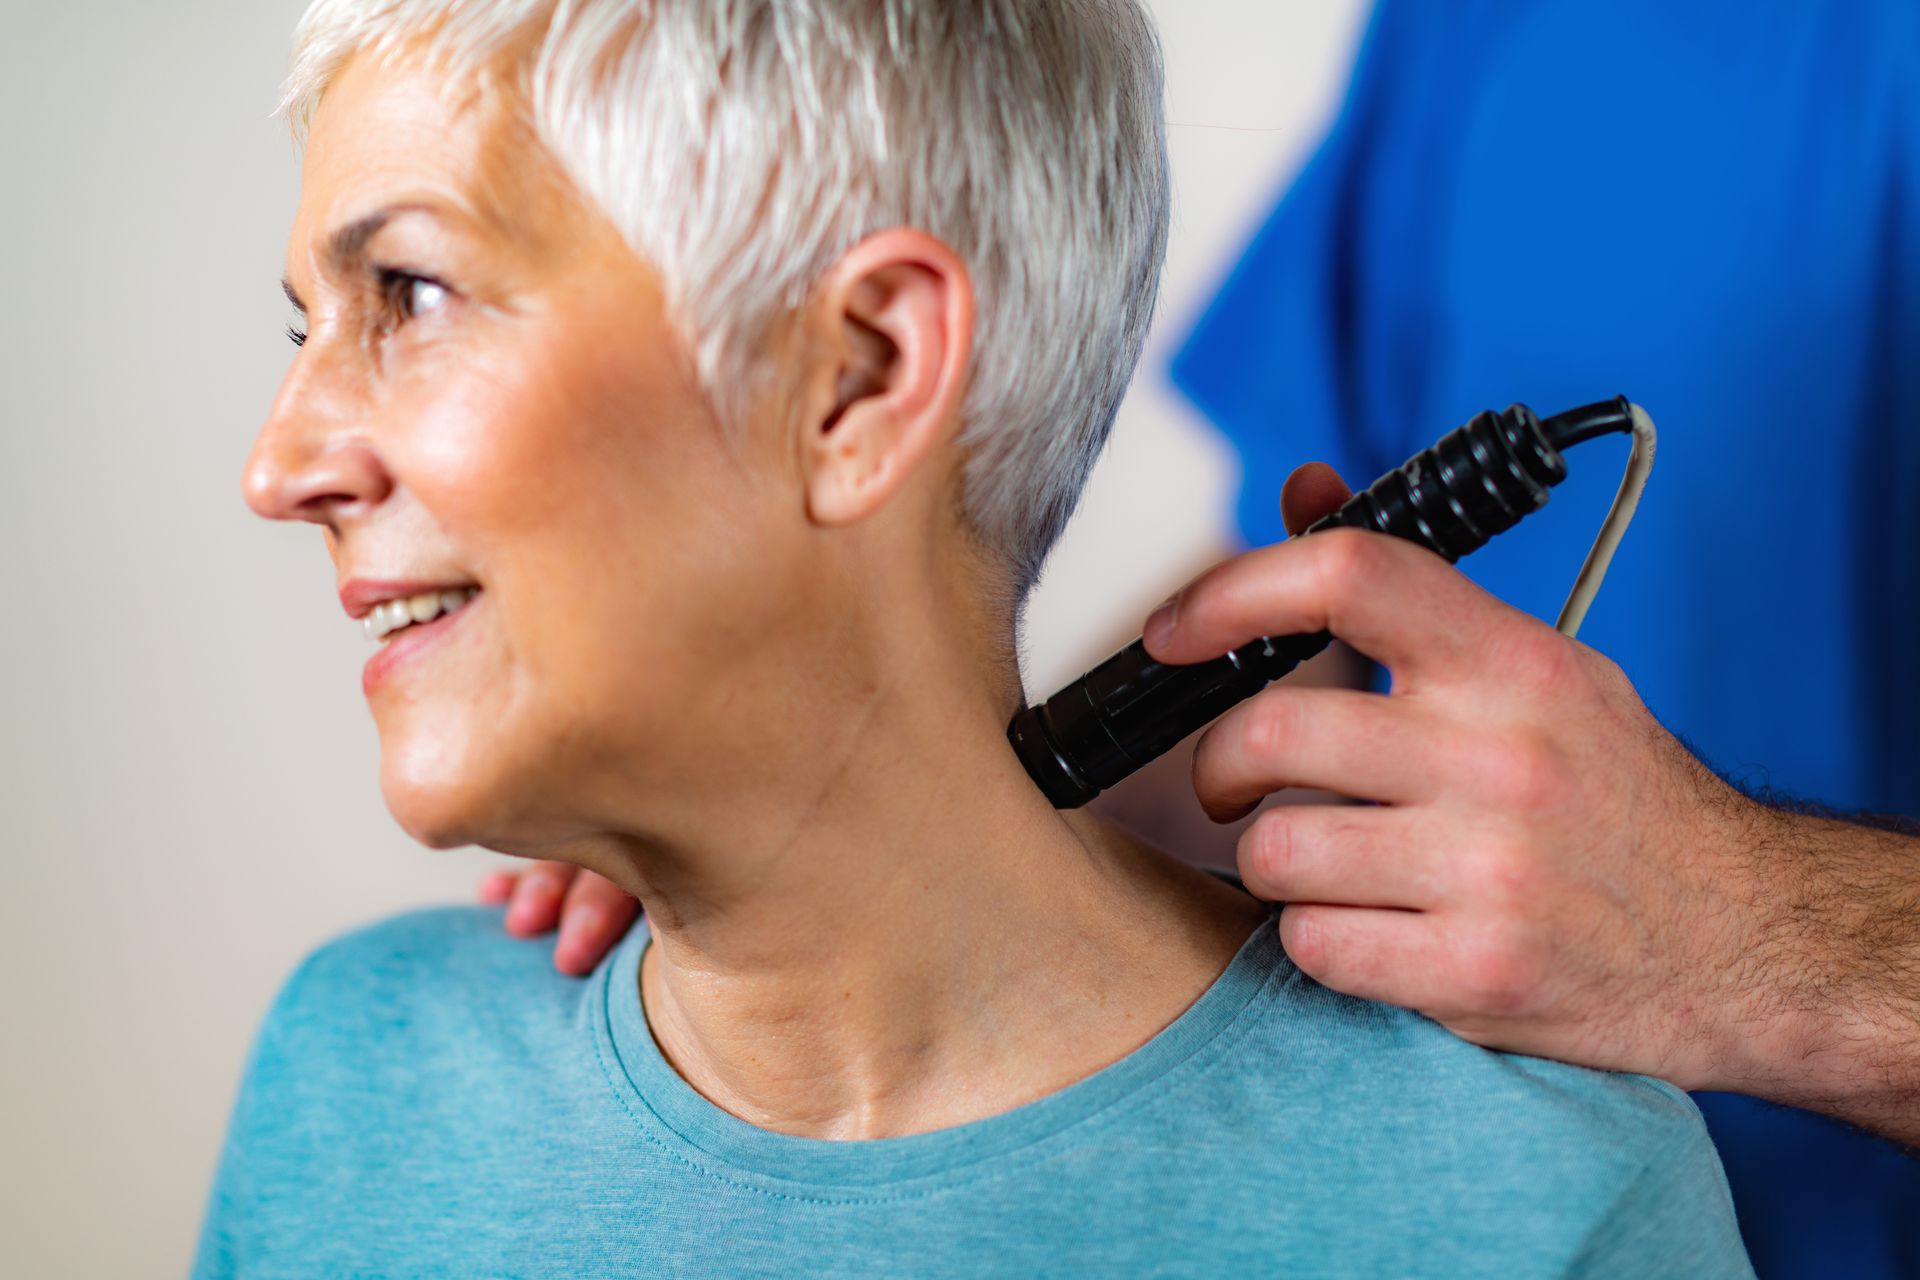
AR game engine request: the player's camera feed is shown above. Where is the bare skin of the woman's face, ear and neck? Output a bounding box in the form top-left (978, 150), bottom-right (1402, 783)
top-left (246, 52), bottom-right (1265, 1138)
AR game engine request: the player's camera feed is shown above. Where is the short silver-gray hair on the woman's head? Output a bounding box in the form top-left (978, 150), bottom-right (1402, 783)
top-left (282, 0), bottom-right (1169, 599)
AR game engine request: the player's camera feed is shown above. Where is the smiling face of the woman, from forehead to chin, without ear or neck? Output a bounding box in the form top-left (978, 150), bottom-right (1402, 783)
top-left (246, 59), bottom-right (810, 852)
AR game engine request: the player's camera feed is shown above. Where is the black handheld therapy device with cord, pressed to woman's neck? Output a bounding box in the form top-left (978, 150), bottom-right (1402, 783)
top-left (1006, 397), bottom-right (1651, 810)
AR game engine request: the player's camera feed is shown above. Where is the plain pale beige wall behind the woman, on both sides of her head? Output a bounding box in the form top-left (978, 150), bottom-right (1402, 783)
top-left (0, 0), bottom-right (1361, 1276)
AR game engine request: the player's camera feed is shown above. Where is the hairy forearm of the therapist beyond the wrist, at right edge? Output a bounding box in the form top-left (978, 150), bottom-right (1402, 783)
top-left (1720, 804), bottom-right (1920, 1146)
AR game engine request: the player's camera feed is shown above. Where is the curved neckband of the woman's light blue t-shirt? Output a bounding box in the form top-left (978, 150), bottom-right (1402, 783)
top-left (589, 912), bottom-right (1292, 1199)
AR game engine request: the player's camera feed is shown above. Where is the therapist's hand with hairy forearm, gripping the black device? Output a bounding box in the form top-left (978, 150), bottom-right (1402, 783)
top-left (1146, 466), bottom-right (1920, 1140)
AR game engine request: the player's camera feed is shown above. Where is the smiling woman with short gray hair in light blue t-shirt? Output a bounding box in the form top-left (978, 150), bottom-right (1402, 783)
top-left (198, 0), bottom-right (1747, 1276)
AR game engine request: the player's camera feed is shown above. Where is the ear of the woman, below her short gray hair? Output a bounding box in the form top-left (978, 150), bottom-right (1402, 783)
top-left (799, 230), bottom-right (973, 526)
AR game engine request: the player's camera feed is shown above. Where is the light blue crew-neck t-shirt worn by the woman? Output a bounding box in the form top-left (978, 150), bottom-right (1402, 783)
top-left (194, 908), bottom-right (1753, 1280)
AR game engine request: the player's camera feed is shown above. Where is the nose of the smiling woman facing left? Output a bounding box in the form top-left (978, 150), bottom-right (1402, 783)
top-left (240, 364), bottom-right (394, 526)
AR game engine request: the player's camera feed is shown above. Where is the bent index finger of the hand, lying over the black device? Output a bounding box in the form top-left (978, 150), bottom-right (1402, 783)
top-left (1146, 530), bottom-right (1507, 679)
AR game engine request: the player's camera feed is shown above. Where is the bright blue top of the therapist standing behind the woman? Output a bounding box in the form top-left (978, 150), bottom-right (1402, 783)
top-left (1173, 0), bottom-right (1920, 1276)
